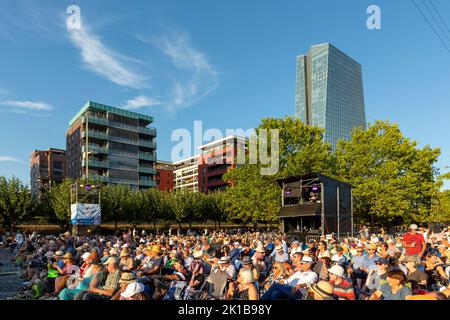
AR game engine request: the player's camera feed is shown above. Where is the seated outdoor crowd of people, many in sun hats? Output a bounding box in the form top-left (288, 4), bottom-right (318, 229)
top-left (0, 224), bottom-right (450, 300)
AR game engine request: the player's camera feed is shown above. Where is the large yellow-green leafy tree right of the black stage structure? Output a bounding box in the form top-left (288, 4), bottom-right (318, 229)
top-left (336, 121), bottom-right (440, 225)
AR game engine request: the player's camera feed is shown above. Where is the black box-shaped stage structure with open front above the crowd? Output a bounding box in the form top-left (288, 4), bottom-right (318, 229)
top-left (277, 173), bottom-right (353, 241)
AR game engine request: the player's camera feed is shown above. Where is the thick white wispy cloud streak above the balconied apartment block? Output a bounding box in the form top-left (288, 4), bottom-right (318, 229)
top-left (68, 21), bottom-right (145, 89)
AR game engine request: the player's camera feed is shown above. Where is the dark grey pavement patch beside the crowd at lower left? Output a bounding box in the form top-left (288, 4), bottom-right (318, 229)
top-left (0, 248), bottom-right (23, 300)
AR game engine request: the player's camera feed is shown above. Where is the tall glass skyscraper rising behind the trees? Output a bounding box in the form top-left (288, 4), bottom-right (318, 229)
top-left (295, 43), bottom-right (366, 149)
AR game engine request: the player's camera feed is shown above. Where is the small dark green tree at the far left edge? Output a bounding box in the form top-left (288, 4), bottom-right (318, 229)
top-left (0, 176), bottom-right (31, 228)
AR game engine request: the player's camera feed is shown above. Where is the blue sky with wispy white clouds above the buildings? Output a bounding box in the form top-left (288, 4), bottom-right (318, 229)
top-left (0, 0), bottom-right (450, 186)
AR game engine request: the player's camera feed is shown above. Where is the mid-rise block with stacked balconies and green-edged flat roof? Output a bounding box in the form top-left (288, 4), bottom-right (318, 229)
top-left (66, 101), bottom-right (156, 189)
